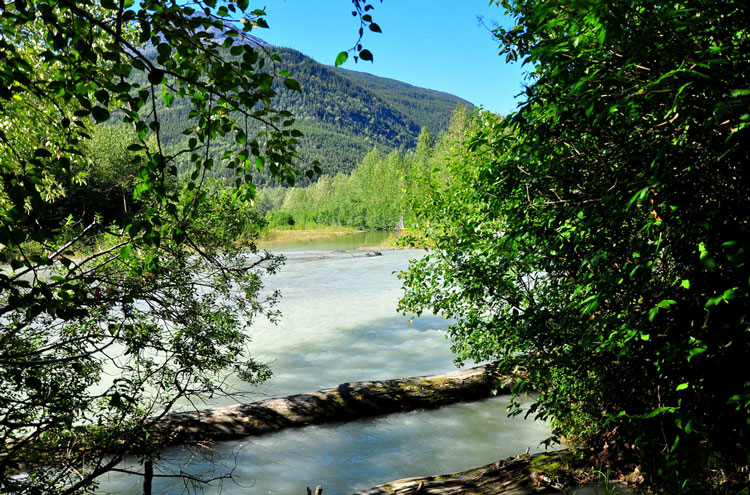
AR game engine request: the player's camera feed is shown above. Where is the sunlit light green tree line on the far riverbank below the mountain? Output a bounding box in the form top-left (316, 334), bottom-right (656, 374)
top-left (258, 106), bottom-right (471, 230)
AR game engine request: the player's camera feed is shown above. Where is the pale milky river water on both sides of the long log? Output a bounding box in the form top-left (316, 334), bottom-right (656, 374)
top-left (99, 233), bottom-right (549, 495)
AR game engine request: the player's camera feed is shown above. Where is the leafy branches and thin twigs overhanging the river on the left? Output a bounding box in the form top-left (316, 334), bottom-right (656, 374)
top-left (0, 0), bottom-right (300, 494)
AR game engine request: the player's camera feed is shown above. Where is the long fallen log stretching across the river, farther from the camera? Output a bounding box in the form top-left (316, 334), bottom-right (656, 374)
top-left (155, 364), bottom-right (513, 445)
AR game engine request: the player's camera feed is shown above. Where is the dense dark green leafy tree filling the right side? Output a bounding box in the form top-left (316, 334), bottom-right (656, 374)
top-left (401, 0), bottom-right (750, 493)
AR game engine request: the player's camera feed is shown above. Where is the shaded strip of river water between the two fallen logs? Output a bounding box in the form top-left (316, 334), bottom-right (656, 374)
top-left (102, 396), bottom-right (549, 495)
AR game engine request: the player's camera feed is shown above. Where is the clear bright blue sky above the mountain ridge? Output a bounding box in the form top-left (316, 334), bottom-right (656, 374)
top-left (251, 0), bottom-right (523, 114)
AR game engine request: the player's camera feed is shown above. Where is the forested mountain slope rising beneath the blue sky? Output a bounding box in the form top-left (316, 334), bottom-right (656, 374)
top-left (142, 38), bottom-right (474, 184)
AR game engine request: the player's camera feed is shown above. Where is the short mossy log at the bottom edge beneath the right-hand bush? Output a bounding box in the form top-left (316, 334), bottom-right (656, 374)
top-left (355, 450), bottom-right (584, 495)
